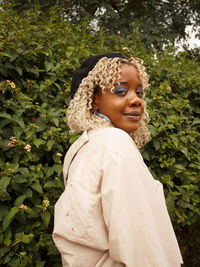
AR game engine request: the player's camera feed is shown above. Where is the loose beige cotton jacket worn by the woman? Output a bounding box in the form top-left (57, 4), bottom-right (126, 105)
top-left (53, 127), bottom-right (182, 267)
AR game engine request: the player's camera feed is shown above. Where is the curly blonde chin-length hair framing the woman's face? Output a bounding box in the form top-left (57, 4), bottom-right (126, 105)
top-left (67, 57), bottom-right (151, 148)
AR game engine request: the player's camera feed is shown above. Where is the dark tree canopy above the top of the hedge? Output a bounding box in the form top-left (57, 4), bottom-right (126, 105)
top-left (3, 0), bottom-right (200, 49)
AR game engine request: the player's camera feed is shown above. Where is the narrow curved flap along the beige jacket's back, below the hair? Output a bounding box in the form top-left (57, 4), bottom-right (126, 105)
top-left (63, 131), bottom-right (89, 184)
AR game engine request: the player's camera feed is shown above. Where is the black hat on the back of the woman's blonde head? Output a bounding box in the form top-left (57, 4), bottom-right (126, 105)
top-left (71, 53), bottom-right (126, 98)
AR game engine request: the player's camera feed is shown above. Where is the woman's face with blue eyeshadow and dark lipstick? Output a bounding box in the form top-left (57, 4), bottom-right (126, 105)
top-left (93, 63), bottom-right (144, 133)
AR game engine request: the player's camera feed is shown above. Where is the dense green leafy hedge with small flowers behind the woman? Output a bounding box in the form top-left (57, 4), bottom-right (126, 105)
top-left (0, 3), bottom-right (200, 267)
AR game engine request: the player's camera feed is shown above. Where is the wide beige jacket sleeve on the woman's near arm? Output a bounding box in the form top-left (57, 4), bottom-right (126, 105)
top-left (102, 138), bottom-right (182, 267)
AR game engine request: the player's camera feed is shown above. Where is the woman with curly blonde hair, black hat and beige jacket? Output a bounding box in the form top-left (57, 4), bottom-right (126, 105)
top-left (53, 53), bottom-right (182, 267)
